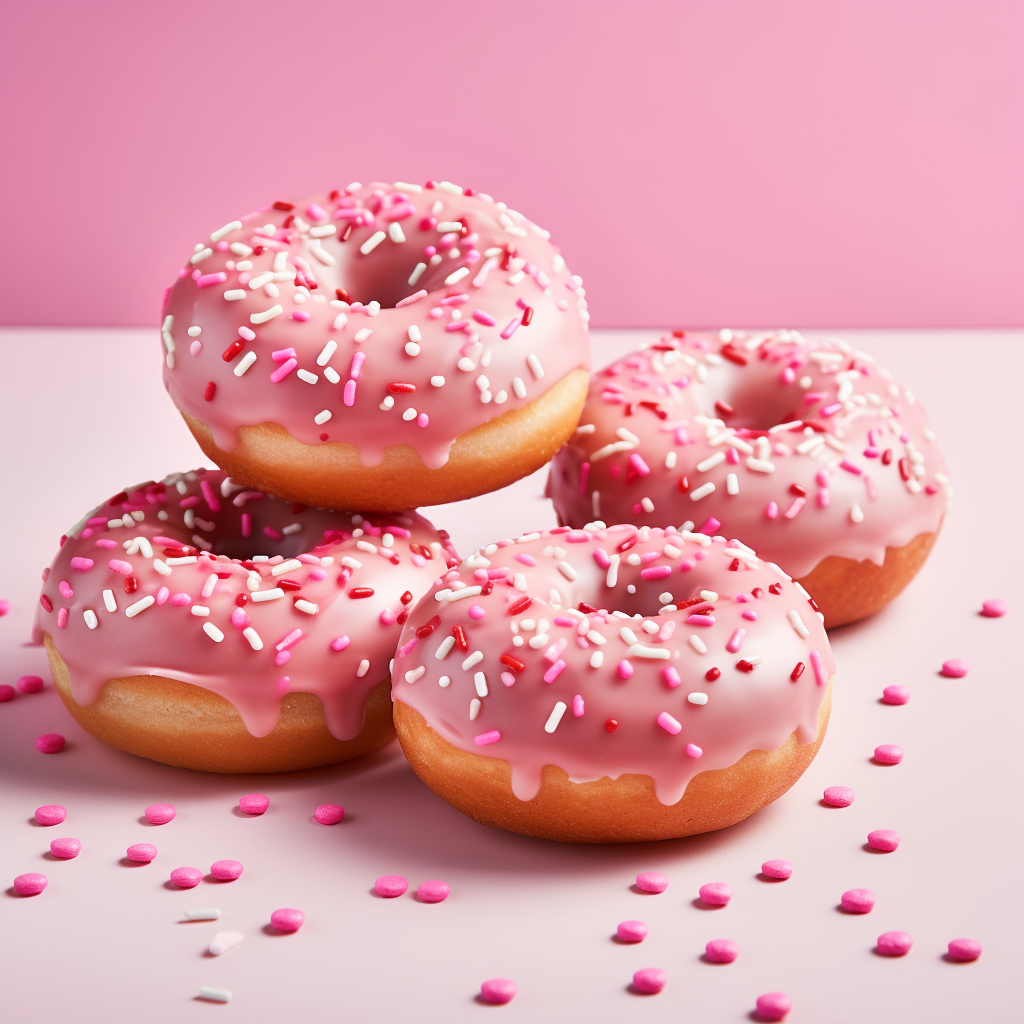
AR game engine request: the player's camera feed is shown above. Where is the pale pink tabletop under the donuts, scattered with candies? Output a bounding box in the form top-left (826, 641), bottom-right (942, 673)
top-left (0, 330), bottom-right (1024, 1024)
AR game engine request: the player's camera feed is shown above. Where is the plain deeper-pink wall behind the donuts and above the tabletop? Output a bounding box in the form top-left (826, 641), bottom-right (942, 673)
top-left (0, 0), bottom-right (1024, 327)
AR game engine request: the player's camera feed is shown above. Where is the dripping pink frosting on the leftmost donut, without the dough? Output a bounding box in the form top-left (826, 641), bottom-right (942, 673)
top-left (34, 469), bottom-right (455, 739)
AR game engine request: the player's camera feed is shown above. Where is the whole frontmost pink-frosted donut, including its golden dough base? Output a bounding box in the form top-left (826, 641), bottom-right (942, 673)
top-left (392, 525), bottom-right (835, 843)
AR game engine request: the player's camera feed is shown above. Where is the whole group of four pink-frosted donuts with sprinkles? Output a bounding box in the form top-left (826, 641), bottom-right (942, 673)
top-left (35, 181), bottom-right (948, 842)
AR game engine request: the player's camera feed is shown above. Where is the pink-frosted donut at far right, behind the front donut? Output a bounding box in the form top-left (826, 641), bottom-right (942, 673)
top-left (547, 331), bottom-right (951, 627)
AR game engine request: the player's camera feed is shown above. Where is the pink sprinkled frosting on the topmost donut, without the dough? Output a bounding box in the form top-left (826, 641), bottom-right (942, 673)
top-left (162, 181), bottom-right (590, 468)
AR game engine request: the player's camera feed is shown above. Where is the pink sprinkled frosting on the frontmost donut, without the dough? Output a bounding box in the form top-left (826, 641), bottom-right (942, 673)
top-left (392, 526), bottom-right (835, 804)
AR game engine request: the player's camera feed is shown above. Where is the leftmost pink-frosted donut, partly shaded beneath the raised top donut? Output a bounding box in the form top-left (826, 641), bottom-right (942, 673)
top-left (34, 469), bottom-right (455, 772)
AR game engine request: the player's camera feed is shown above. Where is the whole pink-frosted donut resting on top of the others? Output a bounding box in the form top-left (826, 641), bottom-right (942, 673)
top-left (162, 181), bottom-right (589, 512)
